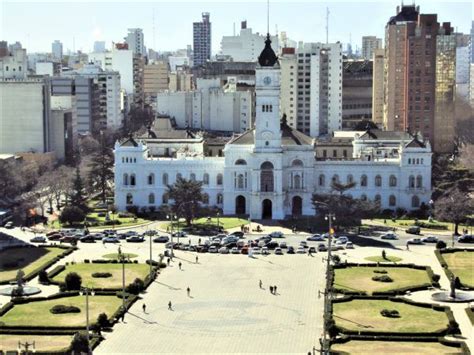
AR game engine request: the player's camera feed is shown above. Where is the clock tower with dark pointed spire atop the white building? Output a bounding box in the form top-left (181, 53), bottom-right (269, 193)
top-left (255, 34), bottom-right (281, 152)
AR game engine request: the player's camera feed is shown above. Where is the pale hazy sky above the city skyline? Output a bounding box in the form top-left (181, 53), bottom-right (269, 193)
top-left (0, 0), bottom-right (474, 54)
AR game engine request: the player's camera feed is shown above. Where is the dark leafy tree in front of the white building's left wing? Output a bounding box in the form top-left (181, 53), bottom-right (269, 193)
top-left (168, 178), bottom-right (203, 226)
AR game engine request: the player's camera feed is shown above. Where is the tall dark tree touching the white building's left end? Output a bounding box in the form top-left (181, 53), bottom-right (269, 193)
top-left (88, 139), bottom-right (114, 204)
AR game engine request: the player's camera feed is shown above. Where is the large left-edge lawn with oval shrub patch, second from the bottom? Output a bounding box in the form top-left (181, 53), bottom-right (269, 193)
top-left (0, 296), bottom-right (122, 327)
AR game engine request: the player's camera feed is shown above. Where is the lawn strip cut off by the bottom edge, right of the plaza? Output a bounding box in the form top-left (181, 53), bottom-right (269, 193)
top-left (331, 340), bottom-right (462, 355)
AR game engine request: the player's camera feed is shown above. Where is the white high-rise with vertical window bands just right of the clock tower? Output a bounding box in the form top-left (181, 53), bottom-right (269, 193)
top-left (281, 43), bottom-right (342, 137)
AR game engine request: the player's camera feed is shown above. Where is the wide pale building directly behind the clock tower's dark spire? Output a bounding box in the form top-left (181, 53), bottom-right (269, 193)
top-left (221, 21), bottom-right (280, 62)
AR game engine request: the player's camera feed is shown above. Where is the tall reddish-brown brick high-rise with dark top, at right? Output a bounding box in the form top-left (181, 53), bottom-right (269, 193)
top-left (384, 5), bottom-right (456, 152)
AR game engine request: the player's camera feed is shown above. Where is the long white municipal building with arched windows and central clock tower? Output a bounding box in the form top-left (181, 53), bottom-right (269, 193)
top-left (115, 38), bottom-right (431, 219)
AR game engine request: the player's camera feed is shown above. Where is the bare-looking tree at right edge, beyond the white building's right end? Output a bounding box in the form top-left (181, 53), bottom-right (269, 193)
top-left (434, 187), bottom-right (474, 235)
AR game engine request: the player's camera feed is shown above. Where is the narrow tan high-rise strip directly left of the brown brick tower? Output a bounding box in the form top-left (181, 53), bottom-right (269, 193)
top-left (372, 49), bottom-right (385, 128)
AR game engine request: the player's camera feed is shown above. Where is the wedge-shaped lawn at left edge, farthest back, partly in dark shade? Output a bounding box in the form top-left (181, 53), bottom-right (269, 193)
top-left (0, 247), bottom-right (65, 282)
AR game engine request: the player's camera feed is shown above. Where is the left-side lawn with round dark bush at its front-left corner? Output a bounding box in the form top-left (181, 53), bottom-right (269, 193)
top-left (53, 263), bottom-right (150, 289)
